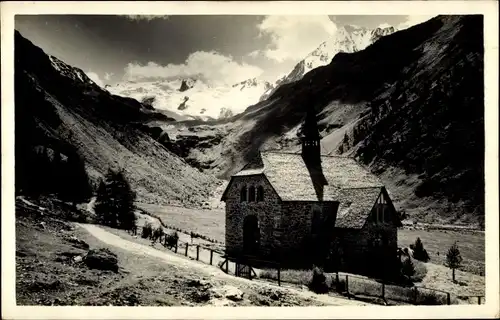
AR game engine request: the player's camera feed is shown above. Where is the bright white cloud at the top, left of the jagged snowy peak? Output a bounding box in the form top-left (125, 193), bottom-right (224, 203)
top-left (257, 15), bottom-right (337, 62)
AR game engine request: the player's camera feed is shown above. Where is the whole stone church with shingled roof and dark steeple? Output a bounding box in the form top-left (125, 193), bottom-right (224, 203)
top-left (222, 113), bottom-right (401, 275)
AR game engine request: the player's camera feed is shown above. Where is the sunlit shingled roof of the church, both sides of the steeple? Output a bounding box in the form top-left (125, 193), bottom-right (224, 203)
top-left (226, 151), bottom-right (383, 228)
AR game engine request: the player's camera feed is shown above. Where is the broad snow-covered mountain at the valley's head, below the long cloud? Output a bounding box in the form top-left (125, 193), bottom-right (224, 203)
top-left (106, 78), bottom-right (271, 120)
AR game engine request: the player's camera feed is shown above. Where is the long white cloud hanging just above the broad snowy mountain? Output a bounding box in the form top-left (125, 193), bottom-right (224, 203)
top-left (124, 51), bottom-right (264, 86)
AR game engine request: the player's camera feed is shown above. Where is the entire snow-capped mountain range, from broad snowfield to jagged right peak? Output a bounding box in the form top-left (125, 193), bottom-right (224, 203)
top-left (106, 26), bottom-right (395, 120)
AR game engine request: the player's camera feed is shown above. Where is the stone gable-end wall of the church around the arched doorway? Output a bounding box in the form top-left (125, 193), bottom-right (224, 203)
top-left (226, 175), bottom-right (281, 258)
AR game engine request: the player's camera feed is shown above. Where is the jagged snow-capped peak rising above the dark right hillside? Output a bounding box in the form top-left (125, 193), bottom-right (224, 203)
top-left (260, 25), bottom-right (396, 100)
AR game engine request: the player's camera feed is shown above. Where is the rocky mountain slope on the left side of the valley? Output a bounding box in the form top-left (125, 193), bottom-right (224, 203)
top-left (15, 31), bottom-right (222, 205)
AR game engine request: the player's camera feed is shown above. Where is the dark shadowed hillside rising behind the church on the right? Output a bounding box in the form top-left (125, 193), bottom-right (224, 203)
top-left (162, 15), bottom-right (484, 223)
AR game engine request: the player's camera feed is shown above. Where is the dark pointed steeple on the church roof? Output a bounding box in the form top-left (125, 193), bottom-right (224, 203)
top-left (302, 109), bottom-right (321, 166)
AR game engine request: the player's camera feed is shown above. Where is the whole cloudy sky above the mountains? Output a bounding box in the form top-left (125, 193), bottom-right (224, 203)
top-left (15, 15), bottom-right (431, 85)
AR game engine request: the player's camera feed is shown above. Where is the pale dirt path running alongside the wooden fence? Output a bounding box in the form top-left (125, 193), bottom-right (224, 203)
top-left (78, 224), bottom-right (367, 306)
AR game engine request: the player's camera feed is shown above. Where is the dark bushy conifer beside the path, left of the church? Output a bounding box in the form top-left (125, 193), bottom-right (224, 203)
top-left (95, 169), bottom-right (136, 230)
